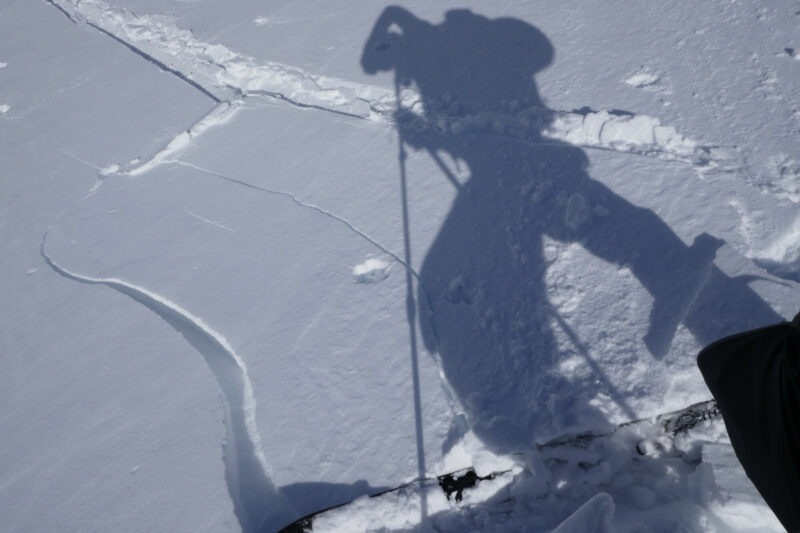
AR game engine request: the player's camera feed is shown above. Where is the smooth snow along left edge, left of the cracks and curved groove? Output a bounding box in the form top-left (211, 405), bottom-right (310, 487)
top-left (0, 0), bottom-right (244, 531)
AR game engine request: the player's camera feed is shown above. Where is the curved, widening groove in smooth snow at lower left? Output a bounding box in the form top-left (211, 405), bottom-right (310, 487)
top-left (40, 233), bottom-right (296, 531)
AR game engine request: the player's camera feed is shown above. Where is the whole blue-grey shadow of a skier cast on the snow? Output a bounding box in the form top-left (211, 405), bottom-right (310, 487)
top-left (361, 6), bottom-right (781, 451)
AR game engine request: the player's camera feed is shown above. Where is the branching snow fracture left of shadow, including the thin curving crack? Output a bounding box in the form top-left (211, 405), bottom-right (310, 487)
top-left (48, 0), bottom-right (466, 412)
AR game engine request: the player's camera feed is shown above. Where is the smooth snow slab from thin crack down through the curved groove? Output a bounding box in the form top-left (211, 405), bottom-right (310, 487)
top-left (43, 159), bottom-right (452, 516)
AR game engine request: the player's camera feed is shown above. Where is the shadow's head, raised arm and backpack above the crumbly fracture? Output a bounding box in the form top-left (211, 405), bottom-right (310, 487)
top-left (361, 6), bottom-right (553, 115)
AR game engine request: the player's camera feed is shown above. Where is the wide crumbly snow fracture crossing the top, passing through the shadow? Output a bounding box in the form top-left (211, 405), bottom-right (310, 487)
top-left (48, 0), bottom-right (739, 180)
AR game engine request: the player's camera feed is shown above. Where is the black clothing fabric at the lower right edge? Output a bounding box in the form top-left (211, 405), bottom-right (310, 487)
top-left (697, 314), bottom-right (800, 533)
